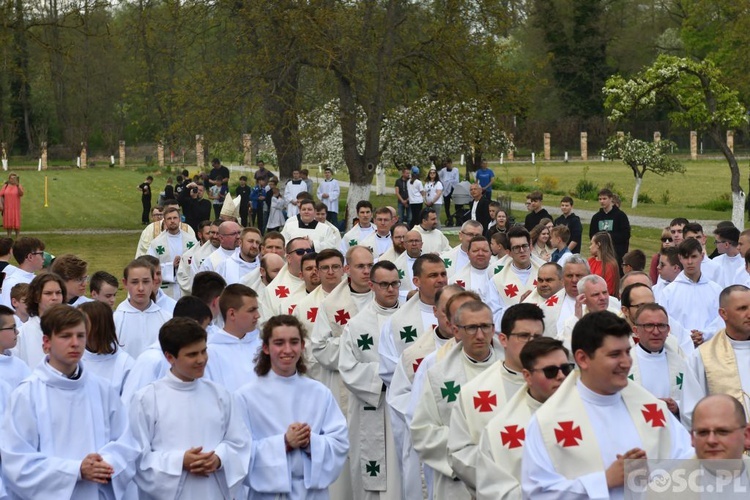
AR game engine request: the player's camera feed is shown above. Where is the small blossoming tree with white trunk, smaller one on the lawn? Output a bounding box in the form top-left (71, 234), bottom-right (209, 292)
top-left (602, 134), bottom-right (685, 208)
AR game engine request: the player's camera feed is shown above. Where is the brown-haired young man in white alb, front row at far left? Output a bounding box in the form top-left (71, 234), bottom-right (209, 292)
top-left (0, 304), bottom-right (140, 500)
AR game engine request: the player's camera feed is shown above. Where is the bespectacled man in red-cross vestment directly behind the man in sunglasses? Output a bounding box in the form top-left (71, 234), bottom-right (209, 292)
top-left (448, 304), bottom-right (544, 494)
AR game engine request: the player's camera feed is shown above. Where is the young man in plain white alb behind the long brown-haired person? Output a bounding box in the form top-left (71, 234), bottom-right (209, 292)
top-left (115, 260), bottom-right (169, 359)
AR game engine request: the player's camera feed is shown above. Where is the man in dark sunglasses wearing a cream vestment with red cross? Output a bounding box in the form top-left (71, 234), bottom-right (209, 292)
top-left (476, 338), bottom-right (575, 500)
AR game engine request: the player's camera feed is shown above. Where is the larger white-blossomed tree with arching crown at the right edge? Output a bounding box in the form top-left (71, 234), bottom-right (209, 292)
top-left (604, 55), bottom-right (747, 228)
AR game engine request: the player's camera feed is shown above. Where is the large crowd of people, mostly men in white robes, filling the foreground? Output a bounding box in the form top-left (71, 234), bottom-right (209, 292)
top-left (0, 161), bottom-right (750, 500)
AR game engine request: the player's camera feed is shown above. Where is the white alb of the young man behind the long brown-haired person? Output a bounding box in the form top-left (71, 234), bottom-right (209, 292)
top-left (115, 300), bottom-right (170, 358)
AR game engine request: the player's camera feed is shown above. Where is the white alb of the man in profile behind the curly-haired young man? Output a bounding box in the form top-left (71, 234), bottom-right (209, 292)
top-left (204, 330), bottom-right (262, 393)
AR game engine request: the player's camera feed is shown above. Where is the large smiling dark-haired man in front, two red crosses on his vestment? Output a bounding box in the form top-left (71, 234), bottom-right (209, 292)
top-left (521, 311), bottom-right (693, 499)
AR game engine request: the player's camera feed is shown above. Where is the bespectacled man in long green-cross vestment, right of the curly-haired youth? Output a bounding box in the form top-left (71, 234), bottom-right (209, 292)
top-left (339, 261), bottom-right (402, 500)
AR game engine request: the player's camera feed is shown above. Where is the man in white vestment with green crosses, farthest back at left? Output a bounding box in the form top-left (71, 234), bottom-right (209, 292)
top-left (147, 207), bottom-right (198, 300)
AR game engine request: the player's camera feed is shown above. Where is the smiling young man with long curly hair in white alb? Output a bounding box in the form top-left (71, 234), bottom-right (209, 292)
top-left (236, 315), bottom-right (349, 500)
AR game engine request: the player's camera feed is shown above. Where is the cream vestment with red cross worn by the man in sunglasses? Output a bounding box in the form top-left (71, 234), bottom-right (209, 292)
top-left (476, 385), bottom-right (542, 500)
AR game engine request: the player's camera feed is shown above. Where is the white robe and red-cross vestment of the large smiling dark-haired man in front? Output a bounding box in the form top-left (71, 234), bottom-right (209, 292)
top-left (521, 372), bottom-right (695, 500)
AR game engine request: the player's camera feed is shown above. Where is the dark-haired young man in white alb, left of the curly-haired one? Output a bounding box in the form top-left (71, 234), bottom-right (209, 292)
top-left (130, 318), bottom-right (251, 500)
